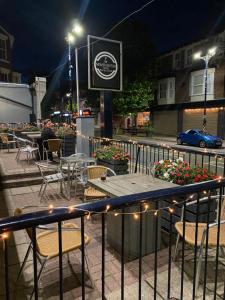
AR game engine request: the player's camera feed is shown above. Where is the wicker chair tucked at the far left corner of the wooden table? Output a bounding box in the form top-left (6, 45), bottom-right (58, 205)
top-left (81, 166), bottom-right (116, 201)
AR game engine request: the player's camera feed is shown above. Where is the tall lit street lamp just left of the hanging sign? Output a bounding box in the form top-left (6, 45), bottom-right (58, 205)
top-left (68, 21), bottom-right (84, 116)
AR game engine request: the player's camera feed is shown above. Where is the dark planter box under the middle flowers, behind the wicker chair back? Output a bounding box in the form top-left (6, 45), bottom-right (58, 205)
top-left (97, 158), bottom-right (128, 175)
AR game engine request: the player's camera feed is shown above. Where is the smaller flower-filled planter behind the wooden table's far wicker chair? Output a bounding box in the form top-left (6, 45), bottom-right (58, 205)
top-left (93, 145), bottom-right (130, 175)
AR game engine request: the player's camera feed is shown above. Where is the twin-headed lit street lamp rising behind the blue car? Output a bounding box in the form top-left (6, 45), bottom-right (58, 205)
top-left (194, 47), bottom-right (216, 132)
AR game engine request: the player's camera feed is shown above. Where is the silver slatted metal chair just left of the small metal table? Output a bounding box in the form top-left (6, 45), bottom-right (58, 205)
top-left (36, 163), bottom-right (66, 200)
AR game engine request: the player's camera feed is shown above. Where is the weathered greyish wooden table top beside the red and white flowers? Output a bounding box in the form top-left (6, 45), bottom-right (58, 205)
top-left (88, 174), bottom-right (177, 197)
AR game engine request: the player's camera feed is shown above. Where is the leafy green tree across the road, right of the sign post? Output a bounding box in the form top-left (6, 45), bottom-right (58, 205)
top-left (113, 79), bottom-right (155, 116)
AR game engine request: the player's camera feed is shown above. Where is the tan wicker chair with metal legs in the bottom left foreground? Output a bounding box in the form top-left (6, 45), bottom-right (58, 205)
top-left (14, 208), bottom-right (93, 299)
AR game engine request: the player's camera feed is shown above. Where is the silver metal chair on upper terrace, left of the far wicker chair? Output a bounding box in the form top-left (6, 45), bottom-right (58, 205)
top-left (16, 138), bottom-right (41, 164)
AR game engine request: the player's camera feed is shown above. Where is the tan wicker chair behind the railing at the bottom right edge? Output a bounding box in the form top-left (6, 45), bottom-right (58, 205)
top-left (174, 196), bottom-right (225, 293)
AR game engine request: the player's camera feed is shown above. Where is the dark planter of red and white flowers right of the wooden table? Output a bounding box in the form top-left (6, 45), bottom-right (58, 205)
top-left (152, 158), bottom-right (217, 232)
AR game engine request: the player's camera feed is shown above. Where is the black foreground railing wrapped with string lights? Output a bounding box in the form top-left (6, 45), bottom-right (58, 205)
top-left (0, 179), bottom-right (225, 300)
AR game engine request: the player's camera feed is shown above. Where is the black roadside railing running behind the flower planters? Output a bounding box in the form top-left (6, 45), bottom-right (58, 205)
top-left (90, 138), bottom-right (225, 176)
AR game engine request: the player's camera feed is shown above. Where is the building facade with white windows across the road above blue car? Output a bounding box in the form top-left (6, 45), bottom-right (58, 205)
top-left (151, 31), bottom-right (225, 138)
